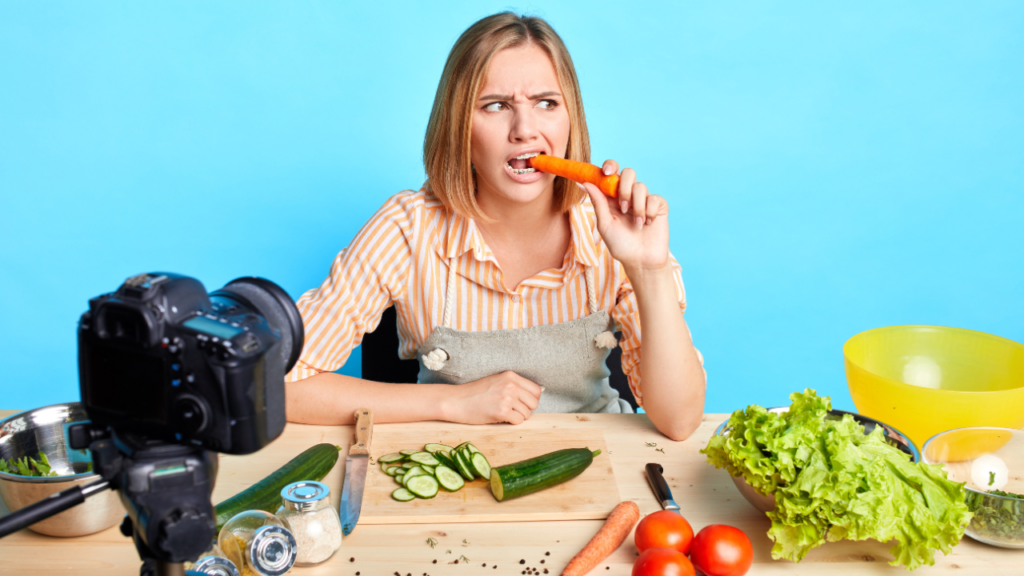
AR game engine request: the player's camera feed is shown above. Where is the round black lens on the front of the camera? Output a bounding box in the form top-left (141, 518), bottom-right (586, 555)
top-left (211, 277), bottom-right (305, 374)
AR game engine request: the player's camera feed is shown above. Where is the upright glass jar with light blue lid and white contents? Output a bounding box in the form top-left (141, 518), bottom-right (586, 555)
top-left (278, 481), bottom-right (341, 566)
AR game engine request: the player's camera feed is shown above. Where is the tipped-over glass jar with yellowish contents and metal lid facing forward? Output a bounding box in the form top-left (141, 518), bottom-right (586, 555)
top-left (217, 510), bottom-right (297, 576)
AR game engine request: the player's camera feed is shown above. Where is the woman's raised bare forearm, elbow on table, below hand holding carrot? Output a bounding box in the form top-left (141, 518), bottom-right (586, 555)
top-left (626, 266), bottom-right (705, 441)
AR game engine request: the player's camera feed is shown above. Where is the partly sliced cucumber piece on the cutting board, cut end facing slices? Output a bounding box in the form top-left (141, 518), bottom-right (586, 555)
top-left (490, 448), bottom-right (601, 502)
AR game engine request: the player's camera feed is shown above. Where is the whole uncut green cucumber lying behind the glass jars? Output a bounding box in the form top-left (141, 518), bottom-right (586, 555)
top-left (214, 444), bottom-right (341, 533)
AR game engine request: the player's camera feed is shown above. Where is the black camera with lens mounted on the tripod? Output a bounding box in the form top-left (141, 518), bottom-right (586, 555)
top-left (78, 273), bottom-right (304, 454)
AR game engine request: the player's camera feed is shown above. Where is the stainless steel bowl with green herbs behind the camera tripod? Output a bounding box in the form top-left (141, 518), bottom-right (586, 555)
top-left (0, 402), bottom-right (125, 536)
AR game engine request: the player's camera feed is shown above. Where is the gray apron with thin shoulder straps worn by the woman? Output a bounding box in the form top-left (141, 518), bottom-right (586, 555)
top-left (418, 259), bottom-right (633, 414)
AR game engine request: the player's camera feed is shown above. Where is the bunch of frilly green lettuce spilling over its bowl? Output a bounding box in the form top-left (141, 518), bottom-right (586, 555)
top-left (700, 388), bottom-right (971, 570)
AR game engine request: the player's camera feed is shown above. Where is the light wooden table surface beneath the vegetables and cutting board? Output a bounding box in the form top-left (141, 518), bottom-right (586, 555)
top-left (0, 410), bottom-right (1024, 576)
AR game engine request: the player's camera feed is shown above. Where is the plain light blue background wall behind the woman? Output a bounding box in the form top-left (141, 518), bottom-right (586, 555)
top-left (0, 0), bottom-right (1024, 412)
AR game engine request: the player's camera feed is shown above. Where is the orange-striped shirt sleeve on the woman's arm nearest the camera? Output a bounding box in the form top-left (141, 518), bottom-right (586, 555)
top-left (285, 195), bottom-right (412, 382)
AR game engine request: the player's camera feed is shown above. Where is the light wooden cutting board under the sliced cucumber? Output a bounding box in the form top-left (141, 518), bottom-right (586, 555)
top-left (359, 426), bottom-right (621, 525)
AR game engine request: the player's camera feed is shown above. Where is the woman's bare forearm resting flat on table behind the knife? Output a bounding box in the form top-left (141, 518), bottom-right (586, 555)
top-left (285, 372), bottom-right (451, 424)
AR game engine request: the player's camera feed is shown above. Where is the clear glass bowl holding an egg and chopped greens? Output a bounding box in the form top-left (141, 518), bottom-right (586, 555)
top-left (923, 426), bottom-right (1024, 549)
